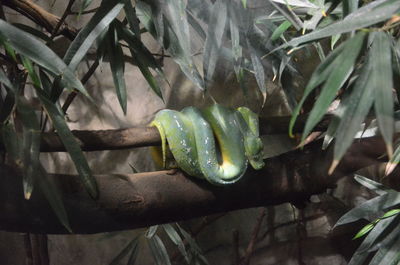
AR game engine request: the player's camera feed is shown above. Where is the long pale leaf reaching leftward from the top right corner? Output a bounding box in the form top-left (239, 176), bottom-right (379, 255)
top-left (275, 0), bottom-right (400, 50)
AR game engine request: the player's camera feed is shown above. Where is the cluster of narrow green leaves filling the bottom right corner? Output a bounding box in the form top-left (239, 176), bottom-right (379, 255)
top-left (336, 176), bottom-right (400, 265)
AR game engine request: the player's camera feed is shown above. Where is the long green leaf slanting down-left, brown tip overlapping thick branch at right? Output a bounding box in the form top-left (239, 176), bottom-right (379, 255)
top-left (333, 49), bottom-right (376, 168)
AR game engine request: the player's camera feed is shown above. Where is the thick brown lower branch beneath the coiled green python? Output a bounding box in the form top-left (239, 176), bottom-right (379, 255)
top-left (0, 135), bottom-right (385, 233)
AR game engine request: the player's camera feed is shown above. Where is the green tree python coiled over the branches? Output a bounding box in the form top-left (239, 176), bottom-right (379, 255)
top-left (150, 104), bottom-right (264, 185)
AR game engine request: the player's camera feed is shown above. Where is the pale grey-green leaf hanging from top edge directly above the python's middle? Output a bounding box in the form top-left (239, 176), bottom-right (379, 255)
top-left (203, 0), bottom-right (228, 82)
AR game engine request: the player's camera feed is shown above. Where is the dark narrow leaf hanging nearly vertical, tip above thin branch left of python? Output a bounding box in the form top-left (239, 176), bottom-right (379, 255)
top-left (106, 26), bottom-right (127, 115)
